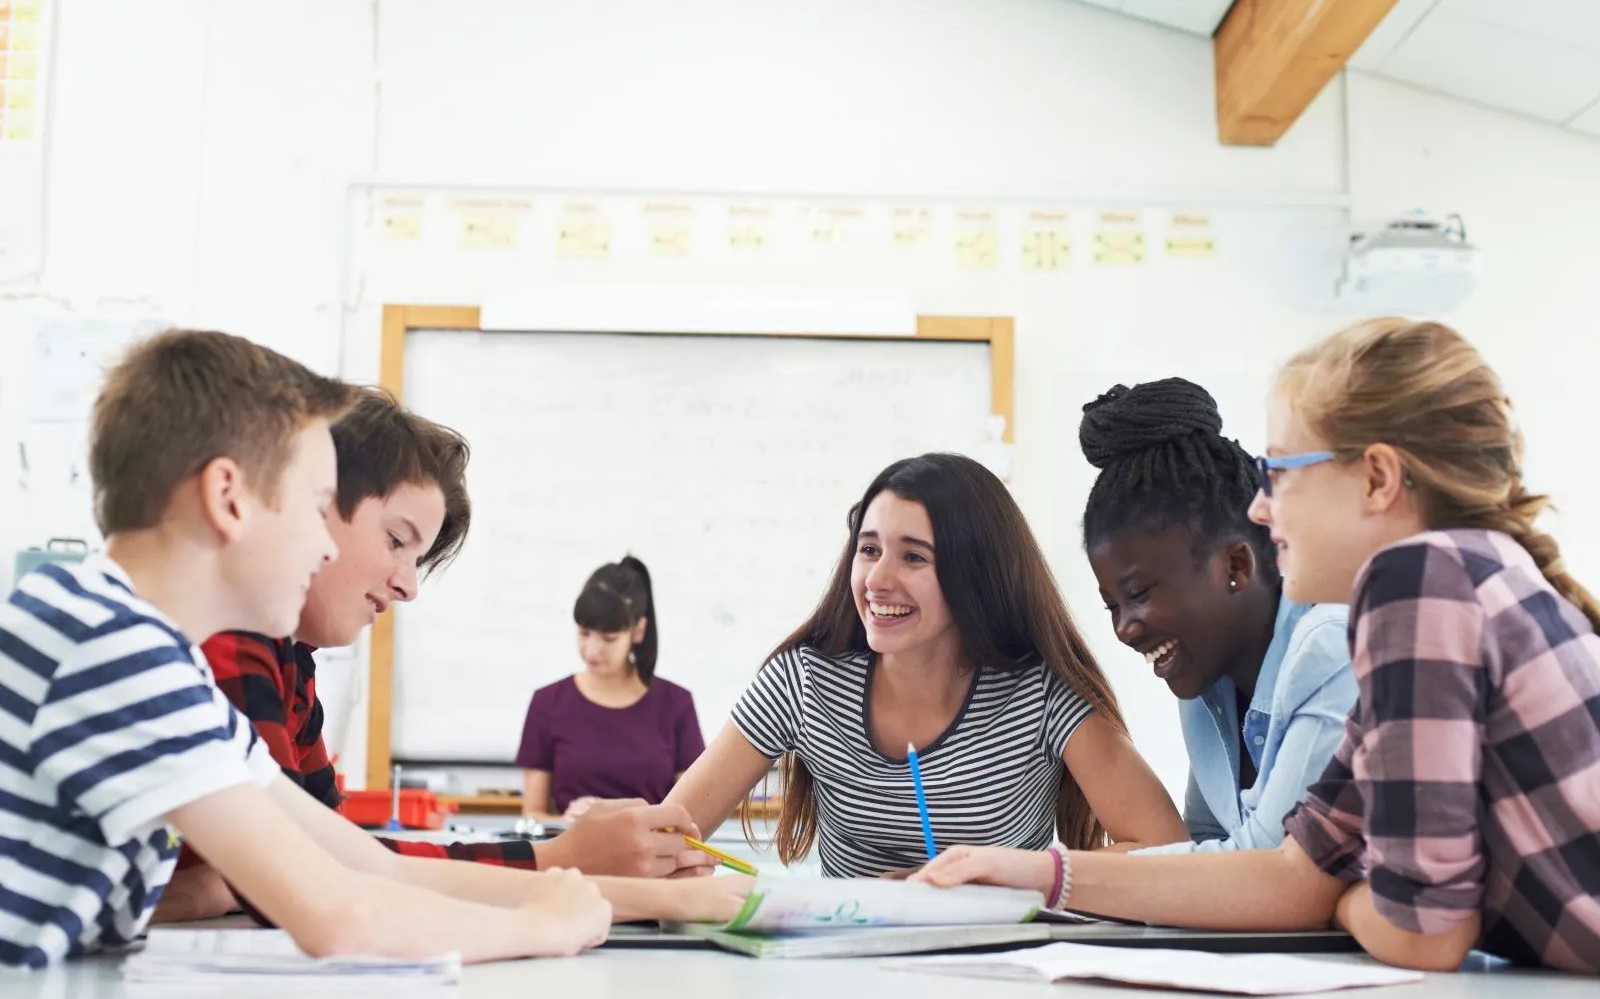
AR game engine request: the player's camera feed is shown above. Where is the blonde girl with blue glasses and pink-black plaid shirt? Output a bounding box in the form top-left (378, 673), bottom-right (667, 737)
top-left (918, 319), bottom-right (1600, 975)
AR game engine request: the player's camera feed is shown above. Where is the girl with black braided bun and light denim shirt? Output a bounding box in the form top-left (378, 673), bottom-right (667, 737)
top-left (1078, 378), bottom-right (1355, 853)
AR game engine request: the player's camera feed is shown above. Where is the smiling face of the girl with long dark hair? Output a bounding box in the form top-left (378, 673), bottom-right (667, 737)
top-left (850, 490), bottom-right (960, 655)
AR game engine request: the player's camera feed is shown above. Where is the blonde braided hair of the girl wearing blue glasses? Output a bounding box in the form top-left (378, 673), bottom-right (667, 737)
top-left (1278, 319), bottom-right (1600, 631)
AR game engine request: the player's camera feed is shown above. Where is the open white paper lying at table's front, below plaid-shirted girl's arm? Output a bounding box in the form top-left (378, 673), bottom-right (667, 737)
top-left (883, 943), bottom-right (1422, 996)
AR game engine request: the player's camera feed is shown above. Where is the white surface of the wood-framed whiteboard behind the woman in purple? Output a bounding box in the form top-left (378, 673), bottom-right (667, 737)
top-left (392, 330), bottom-right (990, 764)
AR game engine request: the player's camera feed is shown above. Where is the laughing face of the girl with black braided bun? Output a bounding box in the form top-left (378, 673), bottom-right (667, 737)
top-left (1090, 525), bottom-right (1254, 700)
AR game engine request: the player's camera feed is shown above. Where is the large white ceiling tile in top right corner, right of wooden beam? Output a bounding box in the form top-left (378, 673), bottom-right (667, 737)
top-left (1381, 6), bottom-right (1600, 122)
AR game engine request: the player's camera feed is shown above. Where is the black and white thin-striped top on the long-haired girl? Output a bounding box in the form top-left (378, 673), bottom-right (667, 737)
top-left (733, 645), bottom-right (1090, 877)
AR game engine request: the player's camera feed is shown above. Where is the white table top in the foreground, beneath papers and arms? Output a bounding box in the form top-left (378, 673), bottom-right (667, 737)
top-left (0, 948), bottom-right (1597, 999)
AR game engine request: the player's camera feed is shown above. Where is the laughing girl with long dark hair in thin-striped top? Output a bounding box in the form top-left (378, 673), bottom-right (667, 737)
top-left (667, 455), bottom-right (1184, 877)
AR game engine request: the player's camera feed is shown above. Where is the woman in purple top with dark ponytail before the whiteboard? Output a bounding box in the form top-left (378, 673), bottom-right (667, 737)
top-left (517, 556), bottom-right (706, 821)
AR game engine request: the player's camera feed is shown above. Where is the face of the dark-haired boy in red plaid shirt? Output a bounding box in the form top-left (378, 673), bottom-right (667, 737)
top-left (294, 482), bottom-right (445, 648)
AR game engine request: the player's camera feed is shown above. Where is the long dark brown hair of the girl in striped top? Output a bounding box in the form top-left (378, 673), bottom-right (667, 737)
top-left (744, 453), bottom-right (1126, 865)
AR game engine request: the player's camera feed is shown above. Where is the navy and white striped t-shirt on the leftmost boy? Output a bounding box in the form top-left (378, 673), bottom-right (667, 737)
top-left (0, 556), bottom-right (278, 967)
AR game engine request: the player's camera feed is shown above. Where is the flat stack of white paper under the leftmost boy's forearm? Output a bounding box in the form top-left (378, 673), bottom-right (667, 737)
top-left (122, 930), bottom-right (461, 994)
